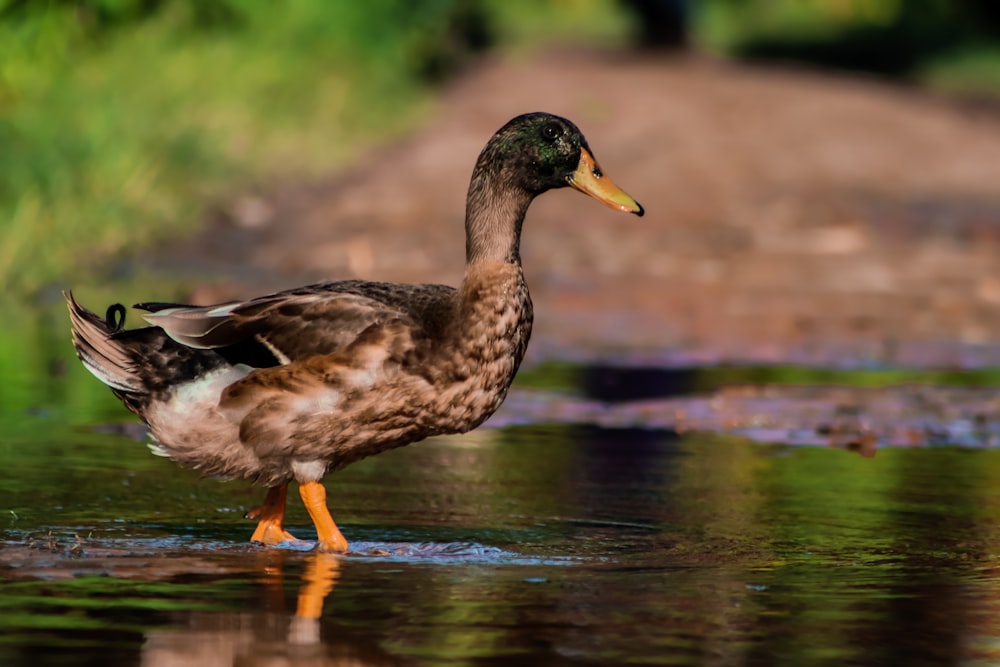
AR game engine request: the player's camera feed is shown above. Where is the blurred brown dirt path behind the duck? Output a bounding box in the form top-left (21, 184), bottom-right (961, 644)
top-left (152, 52), bottom-right (1000, 365)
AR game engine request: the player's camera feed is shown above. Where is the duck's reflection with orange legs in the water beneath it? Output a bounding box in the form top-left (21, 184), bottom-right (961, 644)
top-left (141, 549), bottom-right (405, 667)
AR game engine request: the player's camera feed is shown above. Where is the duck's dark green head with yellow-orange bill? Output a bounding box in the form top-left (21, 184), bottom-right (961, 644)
top-left (479, 112), bottom-right (644, 216)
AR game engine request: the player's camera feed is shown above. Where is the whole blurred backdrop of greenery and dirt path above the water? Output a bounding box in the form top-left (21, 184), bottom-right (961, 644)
top-left (0, 0), bottom-right (1000, 428)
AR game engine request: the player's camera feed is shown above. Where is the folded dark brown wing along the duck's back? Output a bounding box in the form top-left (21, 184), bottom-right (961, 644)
top-left (136, 281), bottom-right (453, 364)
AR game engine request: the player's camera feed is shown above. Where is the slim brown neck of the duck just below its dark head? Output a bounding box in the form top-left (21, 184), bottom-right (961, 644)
top-left (465, 162), bottom-right (534, 266)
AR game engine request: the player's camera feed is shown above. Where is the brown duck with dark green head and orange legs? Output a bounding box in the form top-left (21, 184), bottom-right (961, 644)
top-left (64, 112), bottom-right (644, 553)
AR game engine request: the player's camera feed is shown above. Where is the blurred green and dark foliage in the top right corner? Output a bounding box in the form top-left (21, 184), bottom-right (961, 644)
top-left (695, 0), bottom-right (1000, 82)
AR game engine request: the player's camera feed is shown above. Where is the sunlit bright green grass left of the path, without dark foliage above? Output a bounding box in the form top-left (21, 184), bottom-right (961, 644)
top-left (0, 2), bottom-right (438, 290)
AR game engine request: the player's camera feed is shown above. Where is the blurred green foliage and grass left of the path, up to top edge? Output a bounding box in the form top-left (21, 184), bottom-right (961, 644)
top-left (0, 0), bottom-right (621, 292)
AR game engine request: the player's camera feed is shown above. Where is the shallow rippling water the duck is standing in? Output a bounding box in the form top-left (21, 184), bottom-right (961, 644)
top-left (0, 300), bottom-right (1000, 666)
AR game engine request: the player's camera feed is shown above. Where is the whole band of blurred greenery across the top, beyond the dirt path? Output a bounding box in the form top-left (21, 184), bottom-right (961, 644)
top-left (0, 0), bottom-right (1000, 292)
